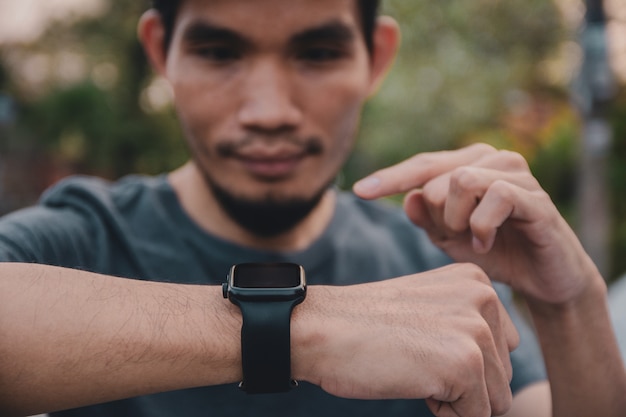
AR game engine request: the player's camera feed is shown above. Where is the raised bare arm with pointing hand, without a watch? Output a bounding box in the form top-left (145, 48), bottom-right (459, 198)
top-left (355, 145), bottom-right (626, 417)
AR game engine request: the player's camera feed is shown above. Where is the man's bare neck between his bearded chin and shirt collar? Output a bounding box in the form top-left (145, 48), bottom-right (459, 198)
top-left (169, 162), bottom-right (336, 251)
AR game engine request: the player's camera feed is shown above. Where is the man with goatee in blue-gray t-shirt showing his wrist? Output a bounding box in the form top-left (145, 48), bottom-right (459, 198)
top-left (0, 0), bottom-right (626, 416)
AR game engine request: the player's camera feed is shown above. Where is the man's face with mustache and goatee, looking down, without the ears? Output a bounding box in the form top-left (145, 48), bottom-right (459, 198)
top-left (166, 0), bottom-right (371, 211)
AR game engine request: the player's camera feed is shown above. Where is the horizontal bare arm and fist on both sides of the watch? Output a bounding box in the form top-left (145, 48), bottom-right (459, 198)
top-left (0, 263), bottom-right (517, 417)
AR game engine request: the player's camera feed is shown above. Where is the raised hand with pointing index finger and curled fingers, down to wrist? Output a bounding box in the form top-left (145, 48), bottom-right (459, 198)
top-left (354, 144), bottom-right (598, 303)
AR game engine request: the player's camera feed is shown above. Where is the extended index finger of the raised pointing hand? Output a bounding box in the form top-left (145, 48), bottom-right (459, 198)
top-left (353, 143), bottom-right (496, 200)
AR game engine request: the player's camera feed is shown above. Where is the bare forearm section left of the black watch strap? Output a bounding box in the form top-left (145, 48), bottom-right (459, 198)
top-left (0, 264), bottom-right (241, 415)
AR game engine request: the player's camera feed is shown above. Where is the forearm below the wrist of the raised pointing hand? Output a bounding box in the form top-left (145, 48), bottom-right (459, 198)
top-left (528, 268), bottom-right (626, 417)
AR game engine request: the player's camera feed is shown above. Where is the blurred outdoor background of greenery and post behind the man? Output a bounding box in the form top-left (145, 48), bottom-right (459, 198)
top-left (0, 0), bottom-right (626, 280)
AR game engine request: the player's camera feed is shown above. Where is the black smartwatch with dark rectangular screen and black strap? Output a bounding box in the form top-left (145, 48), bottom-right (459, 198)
top-left (222, 263), bottom-right (306, 394)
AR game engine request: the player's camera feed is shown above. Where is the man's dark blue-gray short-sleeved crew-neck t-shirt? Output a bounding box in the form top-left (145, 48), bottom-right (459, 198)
top-left (0, 175), bottom-right (545, 417)
